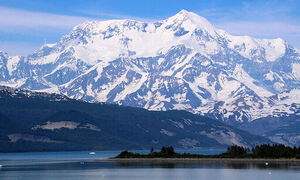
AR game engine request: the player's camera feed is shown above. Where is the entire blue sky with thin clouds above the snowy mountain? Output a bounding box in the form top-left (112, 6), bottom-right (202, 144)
top-left (0, 0), bottom-right (300, 55)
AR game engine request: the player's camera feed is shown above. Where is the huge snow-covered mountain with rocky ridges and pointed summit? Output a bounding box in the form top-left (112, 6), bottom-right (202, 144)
top-left (0, 10), bottom-right (300, 121)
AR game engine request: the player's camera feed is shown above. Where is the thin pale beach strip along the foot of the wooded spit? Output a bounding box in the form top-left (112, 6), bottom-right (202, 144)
top-left (94, 158), bottom-right (300, 164)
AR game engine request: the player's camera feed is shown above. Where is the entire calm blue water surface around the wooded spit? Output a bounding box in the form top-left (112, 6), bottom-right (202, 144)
top-left (0, 150), bottom-right (300, 180)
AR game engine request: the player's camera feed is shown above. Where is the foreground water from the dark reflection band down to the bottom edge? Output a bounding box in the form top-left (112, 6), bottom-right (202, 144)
top-left (0, 160), bottom-right (300, 180)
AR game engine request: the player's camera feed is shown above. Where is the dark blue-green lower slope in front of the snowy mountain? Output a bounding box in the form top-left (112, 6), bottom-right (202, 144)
top-left (0, 86), bottom-right (272, 152)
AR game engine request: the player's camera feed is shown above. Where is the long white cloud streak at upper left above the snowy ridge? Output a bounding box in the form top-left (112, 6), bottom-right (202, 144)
top-left (0, 6), bottom-right (154, 31)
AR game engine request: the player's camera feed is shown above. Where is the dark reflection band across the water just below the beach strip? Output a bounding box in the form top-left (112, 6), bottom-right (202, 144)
top-left (0, 161), bottom-right (300, 172)
